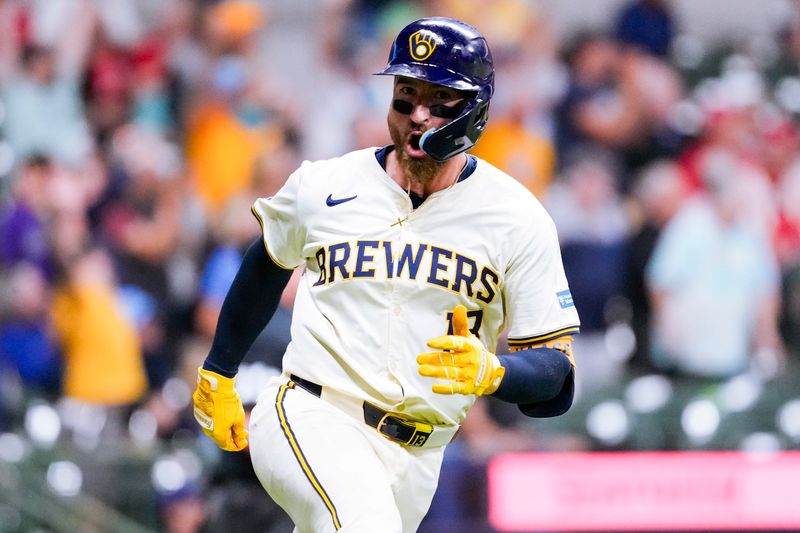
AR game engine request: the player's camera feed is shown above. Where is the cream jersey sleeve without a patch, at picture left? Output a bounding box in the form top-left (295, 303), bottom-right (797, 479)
top-left (252, 167), bottom-right (306, 269)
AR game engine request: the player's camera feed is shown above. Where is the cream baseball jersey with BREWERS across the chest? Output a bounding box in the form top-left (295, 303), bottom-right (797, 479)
top-left (253, 148), bottom-right (579, 425)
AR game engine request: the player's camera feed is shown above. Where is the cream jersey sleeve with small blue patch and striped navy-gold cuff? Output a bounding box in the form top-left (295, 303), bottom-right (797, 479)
top-left (504, 211), bottom-right (580, 349)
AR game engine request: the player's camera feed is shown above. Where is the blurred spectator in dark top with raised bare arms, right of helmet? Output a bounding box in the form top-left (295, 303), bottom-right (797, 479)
top-left (555, 33), bottom-right (683, 183)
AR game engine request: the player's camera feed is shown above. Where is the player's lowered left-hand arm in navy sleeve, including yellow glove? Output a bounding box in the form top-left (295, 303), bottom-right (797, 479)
top-left (192, 238), bottom-right (292, 451)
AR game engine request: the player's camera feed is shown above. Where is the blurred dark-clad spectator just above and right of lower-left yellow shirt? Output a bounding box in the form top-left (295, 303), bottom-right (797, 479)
top-left (96, 124), bottom-right (186, 386)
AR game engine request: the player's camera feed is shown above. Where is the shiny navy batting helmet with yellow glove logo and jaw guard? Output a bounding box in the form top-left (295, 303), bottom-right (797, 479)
top-left (377, 17), bottom-right (494, 161)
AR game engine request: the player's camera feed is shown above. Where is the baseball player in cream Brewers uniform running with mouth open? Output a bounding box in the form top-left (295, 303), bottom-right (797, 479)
top-left (194, 18), bottom-right (579, 533)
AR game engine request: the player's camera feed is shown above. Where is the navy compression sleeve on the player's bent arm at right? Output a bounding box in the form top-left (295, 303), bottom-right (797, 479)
top-left (492, 348), bottom-right (573, 416)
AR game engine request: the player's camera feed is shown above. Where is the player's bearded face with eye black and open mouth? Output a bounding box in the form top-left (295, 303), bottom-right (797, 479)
top-left (388, 76), bottom-right (466, 181)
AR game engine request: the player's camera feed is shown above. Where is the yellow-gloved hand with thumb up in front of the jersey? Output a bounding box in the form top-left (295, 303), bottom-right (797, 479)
top-left (417, 305), bottom-right (506, 396)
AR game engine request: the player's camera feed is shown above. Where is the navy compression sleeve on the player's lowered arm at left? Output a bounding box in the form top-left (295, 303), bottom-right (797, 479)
top-left (203, 238), bottom-right (292, 378)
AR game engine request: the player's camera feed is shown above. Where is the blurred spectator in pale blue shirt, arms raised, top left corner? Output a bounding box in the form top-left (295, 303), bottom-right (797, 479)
top-left (0, 0), bottom-right (96, 166)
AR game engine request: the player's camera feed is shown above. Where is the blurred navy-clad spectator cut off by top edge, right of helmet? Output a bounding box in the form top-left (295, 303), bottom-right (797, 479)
top-left (616, 0), bottom-right (675, 58)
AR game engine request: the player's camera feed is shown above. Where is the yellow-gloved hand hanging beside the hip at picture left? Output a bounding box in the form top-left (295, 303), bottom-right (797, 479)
top-left (192, 367), bottom-right (247, 452)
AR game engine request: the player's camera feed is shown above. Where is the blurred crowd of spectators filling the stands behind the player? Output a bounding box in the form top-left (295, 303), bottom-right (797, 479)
top-left (0, 0), bottom-right (800, 532)
